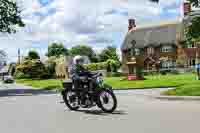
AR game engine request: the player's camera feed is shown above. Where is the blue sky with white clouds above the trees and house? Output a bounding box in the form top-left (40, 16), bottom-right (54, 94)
top-left (0, 0), bottom-right (183, 61)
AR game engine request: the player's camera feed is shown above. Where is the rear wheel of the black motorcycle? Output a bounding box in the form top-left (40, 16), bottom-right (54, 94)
top-left (62, 90), bottom-right (80, 111)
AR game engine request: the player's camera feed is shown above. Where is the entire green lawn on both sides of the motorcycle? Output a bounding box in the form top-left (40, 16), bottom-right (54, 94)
top-left (17, 74), bottom-right (200, 96)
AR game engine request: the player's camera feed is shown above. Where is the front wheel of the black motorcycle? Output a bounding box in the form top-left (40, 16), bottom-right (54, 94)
top-left (98, 90), bottom-right (117, 113)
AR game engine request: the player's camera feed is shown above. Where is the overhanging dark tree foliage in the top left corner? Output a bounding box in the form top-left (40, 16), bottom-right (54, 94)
top-left (0, 0), bottom-right (25, 34)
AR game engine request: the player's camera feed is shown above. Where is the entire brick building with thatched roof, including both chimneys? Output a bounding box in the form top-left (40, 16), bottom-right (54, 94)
top-left (121, 3), bottom-right (200, 74)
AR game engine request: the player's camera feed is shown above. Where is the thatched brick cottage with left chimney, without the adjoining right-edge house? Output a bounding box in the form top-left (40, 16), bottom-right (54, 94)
top-left (121, 19), bottom-right (183, 74)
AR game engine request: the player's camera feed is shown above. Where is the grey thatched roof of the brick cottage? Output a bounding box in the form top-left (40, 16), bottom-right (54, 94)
top-left (121, 22), bottom-right (183, 50)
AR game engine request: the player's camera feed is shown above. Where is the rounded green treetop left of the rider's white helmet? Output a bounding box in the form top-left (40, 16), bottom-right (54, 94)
top-left (46, 43), bottom-right (69, 57)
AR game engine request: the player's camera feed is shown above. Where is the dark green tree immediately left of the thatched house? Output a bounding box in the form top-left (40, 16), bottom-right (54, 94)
top-left (99, 46), bottom-right (119, 62)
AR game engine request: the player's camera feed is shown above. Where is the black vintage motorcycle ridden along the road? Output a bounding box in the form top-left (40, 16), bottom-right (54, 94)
top-left (62, 72), bottom-right (117, 113)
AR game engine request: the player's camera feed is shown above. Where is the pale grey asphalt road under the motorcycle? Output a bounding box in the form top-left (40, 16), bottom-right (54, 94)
top-left (0, 85), bottom-right (200, 133)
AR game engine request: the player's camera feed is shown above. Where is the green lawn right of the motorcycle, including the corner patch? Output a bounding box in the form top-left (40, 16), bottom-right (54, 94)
top-left (106, 74), bottom-right (200, 96)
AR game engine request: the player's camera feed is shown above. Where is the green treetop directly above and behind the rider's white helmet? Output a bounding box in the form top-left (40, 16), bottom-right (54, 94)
top-left (70, 45), bottom-right (98, 62)
